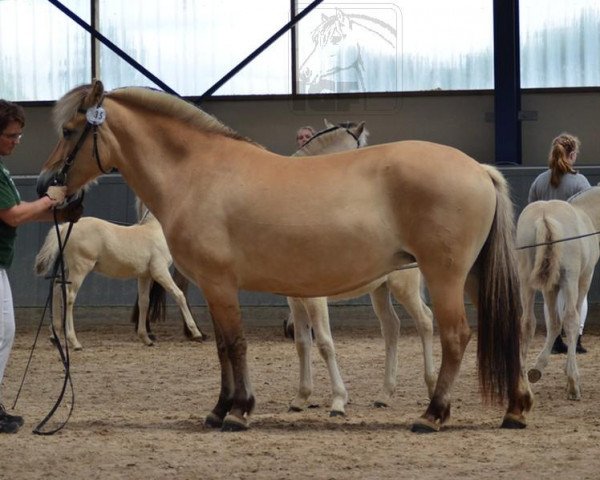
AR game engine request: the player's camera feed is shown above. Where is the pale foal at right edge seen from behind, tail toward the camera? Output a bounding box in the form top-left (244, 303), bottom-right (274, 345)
top-left (517, 187), bottom-right (600, 400)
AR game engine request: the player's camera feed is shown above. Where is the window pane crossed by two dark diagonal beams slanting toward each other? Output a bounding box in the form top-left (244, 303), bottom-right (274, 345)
top-left (99, 0), bottom-right (291, 95)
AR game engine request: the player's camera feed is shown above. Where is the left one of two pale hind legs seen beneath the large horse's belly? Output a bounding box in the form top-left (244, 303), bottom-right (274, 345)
top-left (369, 283), bottom-right (400, 407)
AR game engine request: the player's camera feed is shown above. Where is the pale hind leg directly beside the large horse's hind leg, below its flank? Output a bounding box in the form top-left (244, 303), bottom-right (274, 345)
top-left (387, 269), bottom-right (436, 399)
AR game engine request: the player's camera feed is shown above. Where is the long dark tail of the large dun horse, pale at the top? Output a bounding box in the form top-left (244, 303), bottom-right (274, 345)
top-left (475, 164), bottom-right (528, 409)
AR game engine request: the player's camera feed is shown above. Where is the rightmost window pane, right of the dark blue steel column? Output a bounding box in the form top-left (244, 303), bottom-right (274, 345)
top-left (519, 0), bottom-right (600, 88)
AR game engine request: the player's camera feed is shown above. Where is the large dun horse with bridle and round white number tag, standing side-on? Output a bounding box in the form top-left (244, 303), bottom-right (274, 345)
top-left (37, 81), bottom-right (532, 431)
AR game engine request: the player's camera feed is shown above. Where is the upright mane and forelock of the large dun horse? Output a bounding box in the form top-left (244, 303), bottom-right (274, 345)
top-left (53, 85), bottom-right (255, 143)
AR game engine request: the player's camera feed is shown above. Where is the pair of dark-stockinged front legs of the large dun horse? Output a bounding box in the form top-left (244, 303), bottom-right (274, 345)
top-left (203, 283), bottom-right (255, 431)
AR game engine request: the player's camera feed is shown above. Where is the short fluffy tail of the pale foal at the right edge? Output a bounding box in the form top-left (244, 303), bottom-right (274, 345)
top-left (529, 216), bottom-right (561, 290)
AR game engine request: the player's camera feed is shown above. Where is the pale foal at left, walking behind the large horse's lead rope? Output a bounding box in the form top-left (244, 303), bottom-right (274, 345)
top-left (35, 201), bottom-right (203, 350)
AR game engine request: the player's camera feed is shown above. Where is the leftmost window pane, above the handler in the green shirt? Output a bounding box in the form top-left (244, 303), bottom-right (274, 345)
top-left (0, 0), bottom-right (91, 101)
